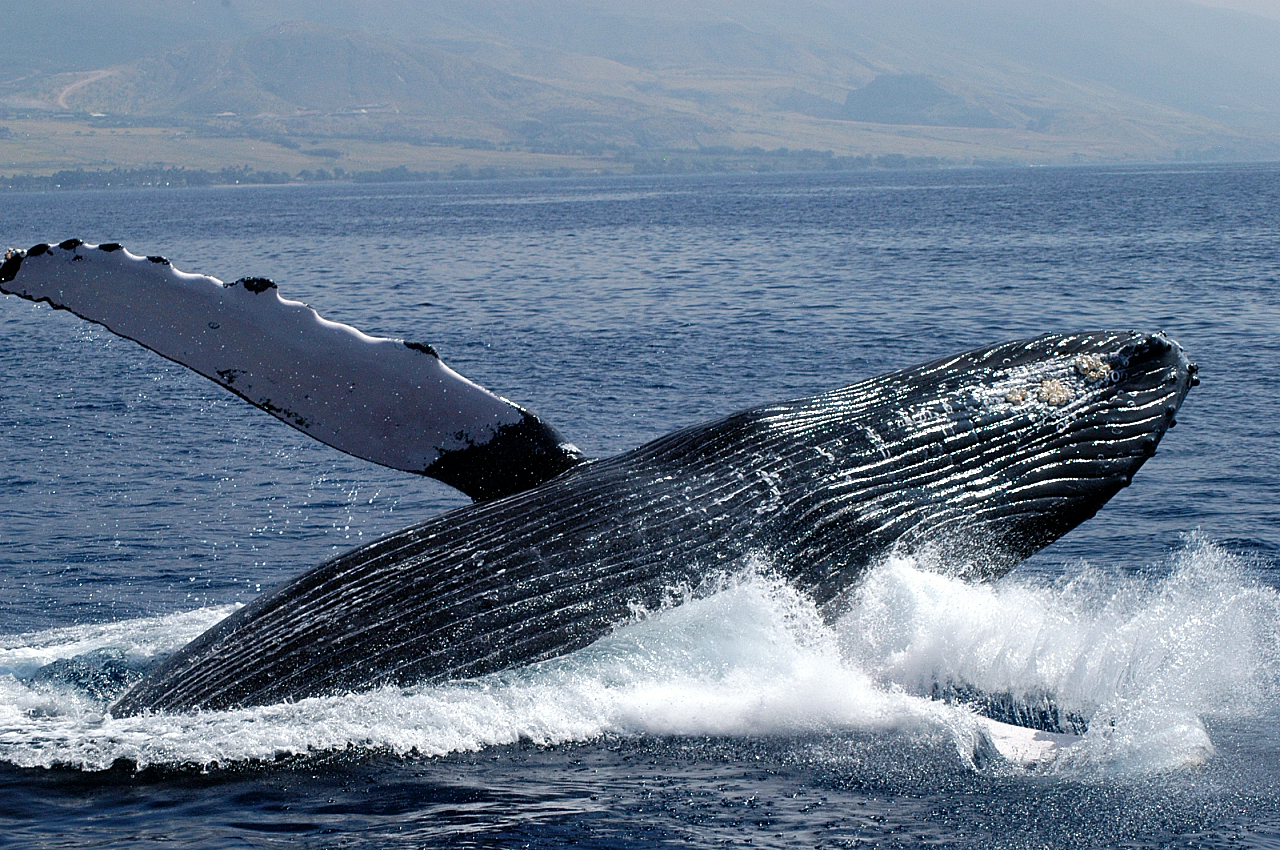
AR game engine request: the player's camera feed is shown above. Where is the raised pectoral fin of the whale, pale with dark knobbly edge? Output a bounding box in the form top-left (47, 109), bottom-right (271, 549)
top-left (0, 239), bottom-right (581, 501)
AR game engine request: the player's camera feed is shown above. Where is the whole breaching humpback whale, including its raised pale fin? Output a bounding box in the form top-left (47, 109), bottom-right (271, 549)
top-left (0, 239), bottom-right (1197, 716)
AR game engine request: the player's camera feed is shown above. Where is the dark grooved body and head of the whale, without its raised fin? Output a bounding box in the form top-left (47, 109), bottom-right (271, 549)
top-left (111, 333), bottom-right (1194, 716)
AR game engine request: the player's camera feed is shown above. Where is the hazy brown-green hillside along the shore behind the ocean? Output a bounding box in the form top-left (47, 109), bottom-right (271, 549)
top-left (0, 0), bottom-right (1280, 174)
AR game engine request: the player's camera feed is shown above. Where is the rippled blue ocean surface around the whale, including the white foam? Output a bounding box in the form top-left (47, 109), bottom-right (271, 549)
top-left (0, 165), bottom-right (1280, 847)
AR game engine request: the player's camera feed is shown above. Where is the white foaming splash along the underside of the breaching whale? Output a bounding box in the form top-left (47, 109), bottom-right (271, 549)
top-left (0, 538), bottom-right (1280, 774)
